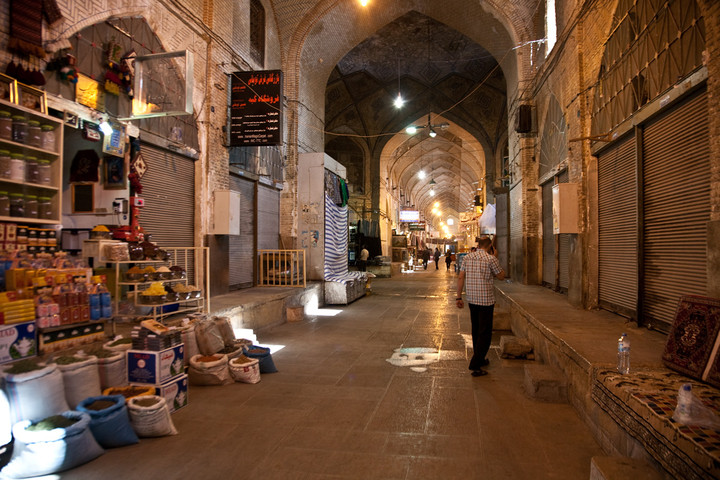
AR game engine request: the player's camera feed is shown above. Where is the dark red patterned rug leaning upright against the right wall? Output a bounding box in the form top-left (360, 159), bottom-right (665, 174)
top-left (662, 295), bottom-right (720, 387)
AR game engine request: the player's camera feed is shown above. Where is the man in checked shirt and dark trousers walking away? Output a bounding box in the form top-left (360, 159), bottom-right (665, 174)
top-left (455, 238), bottom-right (505, 377)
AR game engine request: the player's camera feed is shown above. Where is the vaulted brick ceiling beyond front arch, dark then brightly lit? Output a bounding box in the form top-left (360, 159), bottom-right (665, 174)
top-left (325, 11), bottom-right (507, 219)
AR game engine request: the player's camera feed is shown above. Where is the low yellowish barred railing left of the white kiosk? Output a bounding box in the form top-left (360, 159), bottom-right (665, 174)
top-left (258, 250), bottom-right (305, 288)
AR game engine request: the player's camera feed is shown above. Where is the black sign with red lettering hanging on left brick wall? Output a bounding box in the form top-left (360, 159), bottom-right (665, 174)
top-left (229, 70), bottom-right (282, 147)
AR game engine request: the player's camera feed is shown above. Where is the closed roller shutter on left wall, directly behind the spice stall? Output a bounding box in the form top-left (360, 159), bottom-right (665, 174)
top-left (140, 143), bottom-right (195, 247)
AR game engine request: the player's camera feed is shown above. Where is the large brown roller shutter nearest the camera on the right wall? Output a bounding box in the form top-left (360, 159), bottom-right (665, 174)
top-left (642, 89), bottom-right (710, 329)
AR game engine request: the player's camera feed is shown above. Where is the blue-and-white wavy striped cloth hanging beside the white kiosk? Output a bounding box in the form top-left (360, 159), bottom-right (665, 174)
top-left (324, 193), bottom-right (365, 283)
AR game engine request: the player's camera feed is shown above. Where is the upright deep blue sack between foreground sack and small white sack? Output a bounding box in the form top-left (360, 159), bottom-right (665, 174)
top-left (77, 395), bottom-right (139, 448)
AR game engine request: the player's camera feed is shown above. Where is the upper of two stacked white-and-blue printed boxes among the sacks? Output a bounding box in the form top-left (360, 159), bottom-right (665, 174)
top-left (127, 343), bottom-right (185, 385)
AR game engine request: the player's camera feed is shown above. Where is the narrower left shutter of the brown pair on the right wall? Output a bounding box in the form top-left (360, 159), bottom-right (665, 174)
top-left (598, 135), bottom-right (638, 318)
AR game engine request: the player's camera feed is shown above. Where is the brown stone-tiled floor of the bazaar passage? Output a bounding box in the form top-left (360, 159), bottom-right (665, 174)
top-left (63, 265), bottom-right (602, 480)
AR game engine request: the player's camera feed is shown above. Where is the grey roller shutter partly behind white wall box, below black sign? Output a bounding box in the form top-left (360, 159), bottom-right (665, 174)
top-left (228, 175), bottom-right (255, 289)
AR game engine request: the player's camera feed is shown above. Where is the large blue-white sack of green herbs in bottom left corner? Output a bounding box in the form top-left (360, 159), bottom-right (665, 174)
top-left (0, 411), bottom-right (105, 478)
